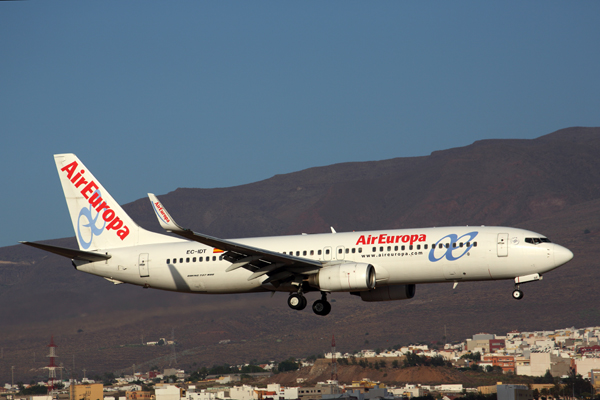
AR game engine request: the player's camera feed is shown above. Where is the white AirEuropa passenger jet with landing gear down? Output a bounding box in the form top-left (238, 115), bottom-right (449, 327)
top-left (21, 154), bottom-right (573, 316)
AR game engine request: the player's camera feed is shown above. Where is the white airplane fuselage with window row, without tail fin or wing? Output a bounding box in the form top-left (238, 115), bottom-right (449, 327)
top-left (78, 227), bottom-right (573, 293)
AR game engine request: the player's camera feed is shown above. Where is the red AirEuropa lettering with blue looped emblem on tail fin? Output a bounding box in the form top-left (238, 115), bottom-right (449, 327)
top-left (60, 161), bottom-right (129, 249)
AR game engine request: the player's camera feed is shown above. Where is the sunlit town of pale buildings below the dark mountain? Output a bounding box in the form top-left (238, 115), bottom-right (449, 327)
top-left (0, 327), bottom-right (600, 400)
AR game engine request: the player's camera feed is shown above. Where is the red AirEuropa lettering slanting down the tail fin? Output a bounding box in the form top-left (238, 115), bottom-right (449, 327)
top-left (60, 161), bottom-right (129, 240)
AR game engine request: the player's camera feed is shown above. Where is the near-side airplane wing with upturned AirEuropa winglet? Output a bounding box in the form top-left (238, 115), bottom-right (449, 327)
top-left (148, 193), bottom-right (323, 286)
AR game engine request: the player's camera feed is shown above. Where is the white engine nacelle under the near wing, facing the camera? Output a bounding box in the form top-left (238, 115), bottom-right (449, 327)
top-left (308, 263), bottom-right (376, 292)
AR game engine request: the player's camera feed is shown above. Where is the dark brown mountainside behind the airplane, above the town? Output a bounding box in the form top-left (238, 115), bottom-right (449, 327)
top-left (0, 128), bottom-right (600, 382)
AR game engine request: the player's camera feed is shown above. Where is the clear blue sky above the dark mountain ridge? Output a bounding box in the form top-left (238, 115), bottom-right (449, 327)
top-left (0, 1), bottom-right (600, 246)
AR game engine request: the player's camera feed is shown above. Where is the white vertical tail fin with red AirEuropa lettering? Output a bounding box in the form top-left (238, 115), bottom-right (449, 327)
top-left (54, 154), bottom-right (181, 250)
